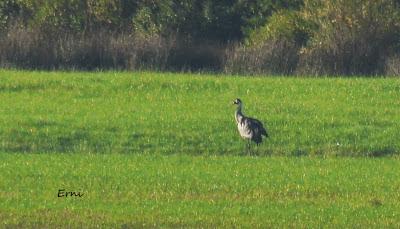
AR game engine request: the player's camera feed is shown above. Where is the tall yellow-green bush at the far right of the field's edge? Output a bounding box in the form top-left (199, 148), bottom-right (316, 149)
top-left (298, 0), bottom-right (400, 75)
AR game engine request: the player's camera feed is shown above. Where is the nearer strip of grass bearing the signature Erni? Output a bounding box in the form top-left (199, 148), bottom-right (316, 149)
top-left (0, 153), bottom-right (400, 228)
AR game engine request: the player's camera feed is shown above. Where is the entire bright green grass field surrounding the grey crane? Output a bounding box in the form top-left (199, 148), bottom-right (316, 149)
top-left (0, 70), bottom-right (400, 228)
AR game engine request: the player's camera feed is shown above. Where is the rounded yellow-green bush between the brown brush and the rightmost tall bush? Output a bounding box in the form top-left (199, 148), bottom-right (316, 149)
top-left (224, 10), bottom-right (308, 75)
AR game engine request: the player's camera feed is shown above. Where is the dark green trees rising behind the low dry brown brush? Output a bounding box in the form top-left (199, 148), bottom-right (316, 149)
top-left (0, 0), bottom-right (301, 41)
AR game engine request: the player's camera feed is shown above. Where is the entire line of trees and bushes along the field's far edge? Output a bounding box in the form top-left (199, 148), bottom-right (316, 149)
top-left (0, 0), bottom-right (400, 75)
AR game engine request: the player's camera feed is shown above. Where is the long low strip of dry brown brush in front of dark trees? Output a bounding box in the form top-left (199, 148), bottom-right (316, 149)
top-left (0, 23), bottom-right (225, 71)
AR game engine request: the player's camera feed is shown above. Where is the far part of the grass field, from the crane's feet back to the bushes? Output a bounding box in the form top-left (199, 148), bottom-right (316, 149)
top-left (0, 70), bottom-right (400, 156)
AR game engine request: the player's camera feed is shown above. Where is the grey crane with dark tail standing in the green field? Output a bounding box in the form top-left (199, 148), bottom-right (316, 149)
top-left (233, 98), bottom-right (269, 151)
